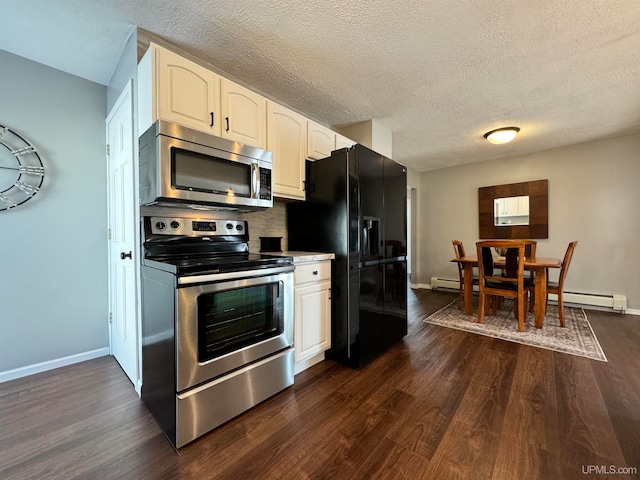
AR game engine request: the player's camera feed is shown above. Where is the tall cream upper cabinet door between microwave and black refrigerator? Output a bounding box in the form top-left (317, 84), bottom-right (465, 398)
top-left (267, 102), bottom-right (307, 200)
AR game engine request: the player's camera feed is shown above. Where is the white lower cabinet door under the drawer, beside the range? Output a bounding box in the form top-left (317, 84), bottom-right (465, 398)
top-left (294, 281), bottom-right (331, 362)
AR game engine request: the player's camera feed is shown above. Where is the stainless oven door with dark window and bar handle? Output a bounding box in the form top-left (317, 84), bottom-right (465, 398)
top-left (176, 266), bottom-right (293, 392)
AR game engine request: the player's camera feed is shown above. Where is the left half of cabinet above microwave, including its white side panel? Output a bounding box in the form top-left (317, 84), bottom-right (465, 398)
top-left (138, 43), bottom-right (222, 136)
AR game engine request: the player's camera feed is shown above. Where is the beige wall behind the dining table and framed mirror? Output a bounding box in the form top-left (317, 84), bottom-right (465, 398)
top-left (414, 135), bottom-right (640, 309)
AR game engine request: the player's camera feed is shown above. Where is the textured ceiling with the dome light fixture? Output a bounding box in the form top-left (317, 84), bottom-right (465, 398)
top-left (0, 0), bottom-right (640, 171)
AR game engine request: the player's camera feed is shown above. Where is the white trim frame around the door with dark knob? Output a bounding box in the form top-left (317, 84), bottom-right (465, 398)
top-left (105, 78), bottom-right (142, 396)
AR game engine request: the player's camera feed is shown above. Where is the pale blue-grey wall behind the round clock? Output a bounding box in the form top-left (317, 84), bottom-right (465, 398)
top-left (0, 50), bottom-right (109, 379)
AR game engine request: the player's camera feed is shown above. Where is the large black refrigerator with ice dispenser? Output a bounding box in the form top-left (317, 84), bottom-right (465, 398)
top-left (287, 145), bottom-right (407, 368)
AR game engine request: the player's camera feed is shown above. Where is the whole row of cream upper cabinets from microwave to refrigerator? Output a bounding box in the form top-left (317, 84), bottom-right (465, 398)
top-left (138, 43), bottom-right (356, 162)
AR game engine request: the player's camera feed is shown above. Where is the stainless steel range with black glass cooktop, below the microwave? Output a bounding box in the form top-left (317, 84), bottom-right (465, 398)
top-left (141, 213), bottom-right (293, 448)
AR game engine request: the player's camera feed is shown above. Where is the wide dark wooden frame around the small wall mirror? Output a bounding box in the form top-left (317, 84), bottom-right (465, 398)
top-left (478, 180), bottom-right (549, 239)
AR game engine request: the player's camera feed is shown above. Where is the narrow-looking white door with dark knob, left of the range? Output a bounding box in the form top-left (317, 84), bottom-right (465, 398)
top-left (107, 82), bottom-right (138, 387)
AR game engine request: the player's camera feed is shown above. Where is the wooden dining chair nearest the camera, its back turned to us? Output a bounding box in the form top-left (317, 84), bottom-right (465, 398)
top-left (476, 240), bottom-right (530, 332)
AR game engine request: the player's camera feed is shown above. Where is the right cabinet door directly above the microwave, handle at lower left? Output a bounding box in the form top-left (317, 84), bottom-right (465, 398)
top-left (221, 78), bottom-right (267, 149)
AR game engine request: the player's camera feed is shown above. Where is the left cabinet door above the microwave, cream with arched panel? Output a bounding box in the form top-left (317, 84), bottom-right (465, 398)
top-left (154, 46), bottom-right (221, 136)
